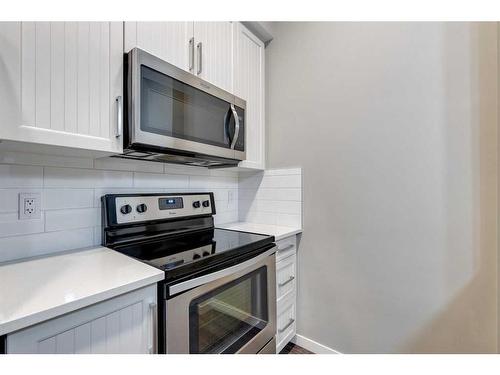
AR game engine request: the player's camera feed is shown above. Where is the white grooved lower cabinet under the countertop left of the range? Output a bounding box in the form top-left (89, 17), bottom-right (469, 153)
top-left (7, 284), bottom-right (157, 354)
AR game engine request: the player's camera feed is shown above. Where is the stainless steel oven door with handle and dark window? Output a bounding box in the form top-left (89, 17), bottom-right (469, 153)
top-left (165, 247), bottom-right (276, 354)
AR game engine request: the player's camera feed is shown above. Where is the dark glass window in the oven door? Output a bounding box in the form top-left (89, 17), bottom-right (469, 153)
top-left (189, 267), bottom-right (269, 353)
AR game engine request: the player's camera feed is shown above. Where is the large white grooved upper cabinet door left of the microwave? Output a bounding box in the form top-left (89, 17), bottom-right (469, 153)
top-left (0, 22), bottom-right (123, 153)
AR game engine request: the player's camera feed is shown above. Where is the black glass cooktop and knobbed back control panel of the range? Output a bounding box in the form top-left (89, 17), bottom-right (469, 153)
top-left (102, 193), bottom-right (274, 288)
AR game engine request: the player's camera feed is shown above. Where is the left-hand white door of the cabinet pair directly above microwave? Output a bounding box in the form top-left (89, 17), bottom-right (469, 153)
top-left (124, 22), bottom-right (194, 73)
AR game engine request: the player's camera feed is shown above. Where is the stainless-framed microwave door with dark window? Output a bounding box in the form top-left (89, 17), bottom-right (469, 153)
top-left (129, 50), bottom-right (242, 159)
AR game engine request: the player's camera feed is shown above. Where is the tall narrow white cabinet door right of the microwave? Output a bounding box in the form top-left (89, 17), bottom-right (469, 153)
top-left (234, 23), bottom-right (266, 169)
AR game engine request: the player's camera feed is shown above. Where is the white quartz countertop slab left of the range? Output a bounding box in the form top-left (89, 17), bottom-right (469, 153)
top-left (0, 247), bottom-right (165, 335)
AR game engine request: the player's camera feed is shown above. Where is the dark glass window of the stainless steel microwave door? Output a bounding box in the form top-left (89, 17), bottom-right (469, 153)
top-left (140, 66), bottom-right (238, 149)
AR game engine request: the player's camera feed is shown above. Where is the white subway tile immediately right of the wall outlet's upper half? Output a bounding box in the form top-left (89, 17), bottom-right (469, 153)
top-left (42, 189), bottom-right (94, 210)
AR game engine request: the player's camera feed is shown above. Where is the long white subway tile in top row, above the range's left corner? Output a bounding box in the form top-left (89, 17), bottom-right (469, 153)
top-left (44, 167), bottom-right (133, 188)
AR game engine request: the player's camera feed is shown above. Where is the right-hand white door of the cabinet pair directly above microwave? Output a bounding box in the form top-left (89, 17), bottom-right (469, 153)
top-left (194, 22), bottom-right (235, 92)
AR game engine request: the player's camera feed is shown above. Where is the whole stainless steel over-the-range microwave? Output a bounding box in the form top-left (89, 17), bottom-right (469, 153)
top-left (119, 48), bottom-right (246, 167)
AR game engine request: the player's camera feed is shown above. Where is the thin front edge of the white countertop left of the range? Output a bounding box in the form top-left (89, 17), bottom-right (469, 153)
top-left (0, 270), bottom-right (165, 335)
